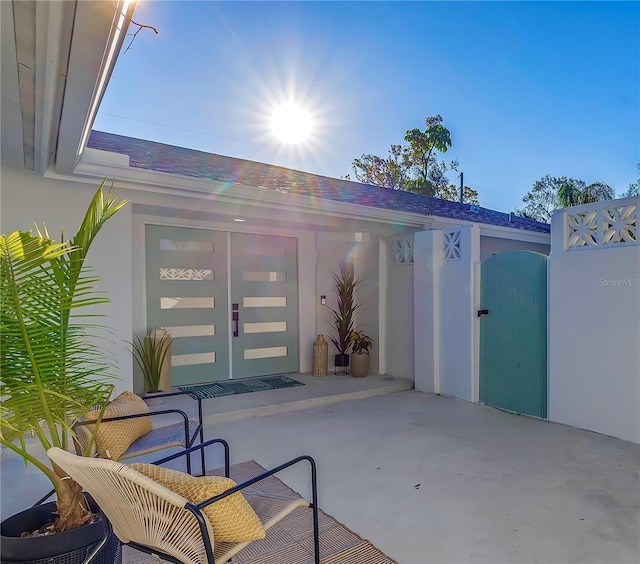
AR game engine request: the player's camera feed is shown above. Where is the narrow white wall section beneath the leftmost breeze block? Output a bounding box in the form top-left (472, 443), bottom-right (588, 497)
top-left (384, 234), bottom-right (415, 380)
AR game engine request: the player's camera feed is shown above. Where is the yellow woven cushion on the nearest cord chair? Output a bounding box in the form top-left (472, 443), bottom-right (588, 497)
top-left (129, 463), bottom-right (265, 542)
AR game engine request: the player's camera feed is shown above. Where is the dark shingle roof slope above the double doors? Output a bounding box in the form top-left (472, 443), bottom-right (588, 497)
top-left (87, 131), bottom-right (550, 233)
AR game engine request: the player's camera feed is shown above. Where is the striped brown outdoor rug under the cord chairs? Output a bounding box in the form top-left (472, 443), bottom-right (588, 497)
top-left (122, 460), bottom-right (397, 564)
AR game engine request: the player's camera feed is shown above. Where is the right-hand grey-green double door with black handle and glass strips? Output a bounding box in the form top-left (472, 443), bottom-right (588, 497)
top-left (231, 233), bottom-right (299, 378)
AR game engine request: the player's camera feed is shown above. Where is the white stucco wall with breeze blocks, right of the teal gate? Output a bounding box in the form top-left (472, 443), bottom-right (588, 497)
top-left (549, 198), bottom-right (640, 443)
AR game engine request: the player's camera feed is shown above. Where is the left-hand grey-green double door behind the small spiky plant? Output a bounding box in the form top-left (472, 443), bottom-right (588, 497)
top-left (146, 225), bottom-right (229, 386)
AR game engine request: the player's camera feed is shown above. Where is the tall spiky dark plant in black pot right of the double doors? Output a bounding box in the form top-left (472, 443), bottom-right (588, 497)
top-left (329, 262), bottom-right (362, 367)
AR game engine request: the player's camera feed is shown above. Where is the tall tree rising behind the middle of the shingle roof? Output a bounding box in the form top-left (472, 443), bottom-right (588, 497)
top-left (346, 115), bottom-right (478, 203)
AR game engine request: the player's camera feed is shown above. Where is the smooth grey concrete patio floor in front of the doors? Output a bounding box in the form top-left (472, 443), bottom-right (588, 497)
top-left (2, 376), bottom-right (640, 564)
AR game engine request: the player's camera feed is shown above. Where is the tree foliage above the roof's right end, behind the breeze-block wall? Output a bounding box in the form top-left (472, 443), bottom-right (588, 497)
top-left (516, 174), bottom-right (615, 223)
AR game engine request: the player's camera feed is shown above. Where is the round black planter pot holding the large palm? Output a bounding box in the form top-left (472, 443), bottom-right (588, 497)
top-left (0, 500), bottom-right (122, 564)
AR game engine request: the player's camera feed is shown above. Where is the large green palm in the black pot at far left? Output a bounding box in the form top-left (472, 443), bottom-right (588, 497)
top-left (0, 181), bottom-right (126, 562)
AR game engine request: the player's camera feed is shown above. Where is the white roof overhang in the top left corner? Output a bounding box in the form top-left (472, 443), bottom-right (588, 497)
top-left (0, 0), bottom-right (135, 174)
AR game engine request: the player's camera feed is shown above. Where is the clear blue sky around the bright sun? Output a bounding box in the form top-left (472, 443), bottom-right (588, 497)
top-left (94, 0), bottom-right (640, 212)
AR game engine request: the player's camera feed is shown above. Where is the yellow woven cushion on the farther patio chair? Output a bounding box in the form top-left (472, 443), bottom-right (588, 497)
top-left (85, 392), bottom-right (152, 460)
